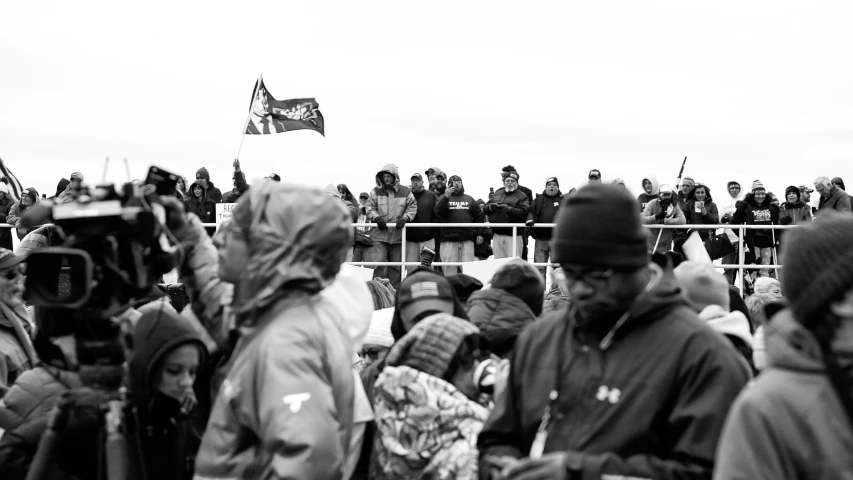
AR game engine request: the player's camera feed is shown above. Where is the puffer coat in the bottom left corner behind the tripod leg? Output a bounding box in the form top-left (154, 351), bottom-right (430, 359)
top-left (0, 364), bottom-right (98, 480)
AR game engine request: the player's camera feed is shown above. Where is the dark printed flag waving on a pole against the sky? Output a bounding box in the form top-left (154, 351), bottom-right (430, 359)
top-left (244, 75), bottom-right (326, 137)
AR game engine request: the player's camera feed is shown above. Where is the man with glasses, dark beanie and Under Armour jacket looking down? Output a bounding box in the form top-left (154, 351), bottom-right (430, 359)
top-left (478, 185), bottom-right (750, 479)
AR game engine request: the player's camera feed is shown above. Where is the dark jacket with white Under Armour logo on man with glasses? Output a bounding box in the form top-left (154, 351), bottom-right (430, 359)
top-left (478, 274), bottom-right (749, 479)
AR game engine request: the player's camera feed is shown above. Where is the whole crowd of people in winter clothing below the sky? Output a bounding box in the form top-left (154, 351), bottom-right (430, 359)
top-left (0, 161), bottom-right (853, 480)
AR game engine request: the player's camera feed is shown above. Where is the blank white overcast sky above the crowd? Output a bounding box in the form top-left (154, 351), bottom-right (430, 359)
top-left (0, 0), bottom-right (853, 201)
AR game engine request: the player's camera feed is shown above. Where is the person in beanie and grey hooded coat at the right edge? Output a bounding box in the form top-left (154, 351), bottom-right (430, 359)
top-left (714, 213), bottom-right (853, 480)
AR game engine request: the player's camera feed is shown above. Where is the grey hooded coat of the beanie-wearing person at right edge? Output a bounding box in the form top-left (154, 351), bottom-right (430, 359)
top-left (714, 311), bottom-right (853, 480)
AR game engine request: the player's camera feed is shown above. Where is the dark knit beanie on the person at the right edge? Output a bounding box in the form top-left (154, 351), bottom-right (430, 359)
top-left (781, 212), bottom-right (853, 328)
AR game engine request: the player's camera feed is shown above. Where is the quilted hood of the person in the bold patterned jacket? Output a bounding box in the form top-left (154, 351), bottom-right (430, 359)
top-left (386, 313), bottom-right (480, 378)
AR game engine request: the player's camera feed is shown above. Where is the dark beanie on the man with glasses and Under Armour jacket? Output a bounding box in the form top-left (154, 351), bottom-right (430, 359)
top-left (551, 184), bottom-right (650, 268)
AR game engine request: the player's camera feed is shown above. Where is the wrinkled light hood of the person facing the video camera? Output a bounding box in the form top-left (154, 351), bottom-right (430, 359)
top-left (232, 181), bottom-right (353, 314)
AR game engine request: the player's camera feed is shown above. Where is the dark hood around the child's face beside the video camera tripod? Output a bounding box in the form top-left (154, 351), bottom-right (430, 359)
top-left (129, 301), bottom-right (208, 415)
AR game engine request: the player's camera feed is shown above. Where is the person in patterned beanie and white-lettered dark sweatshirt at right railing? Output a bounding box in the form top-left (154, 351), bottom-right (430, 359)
top-left (731, 180), bottom-right (779, 277)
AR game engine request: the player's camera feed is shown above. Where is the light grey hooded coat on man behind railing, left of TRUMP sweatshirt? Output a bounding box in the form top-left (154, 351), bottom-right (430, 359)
top-left (366, 164), bottom-right (418, 245)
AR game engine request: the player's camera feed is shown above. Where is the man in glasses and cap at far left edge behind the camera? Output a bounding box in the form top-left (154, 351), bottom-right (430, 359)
top-left (0, 248), bottom-right (38, 397)
